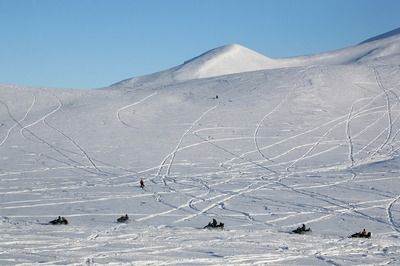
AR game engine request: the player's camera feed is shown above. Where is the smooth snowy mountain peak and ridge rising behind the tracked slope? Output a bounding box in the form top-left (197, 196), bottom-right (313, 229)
top-left (111, 28), bottom-right (400, 89)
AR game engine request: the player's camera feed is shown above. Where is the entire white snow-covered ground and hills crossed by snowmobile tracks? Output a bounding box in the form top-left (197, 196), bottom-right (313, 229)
top-left (0, 28), bottom-right (400, 265)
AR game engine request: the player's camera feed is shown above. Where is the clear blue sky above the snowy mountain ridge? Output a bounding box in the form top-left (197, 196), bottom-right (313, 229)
top-left (0, 0), bottom-right (400, 88)
